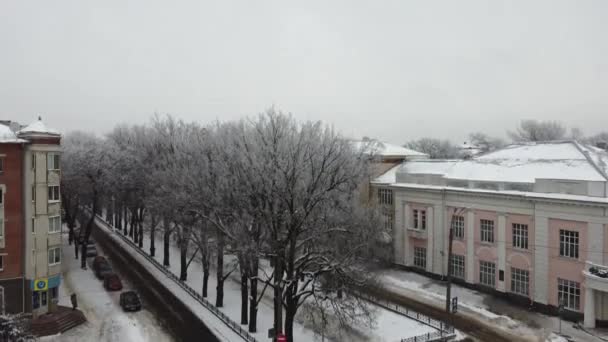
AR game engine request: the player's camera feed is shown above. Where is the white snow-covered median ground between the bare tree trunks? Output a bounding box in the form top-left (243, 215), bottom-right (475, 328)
top-left (104, 222), bottom-right (442, 342)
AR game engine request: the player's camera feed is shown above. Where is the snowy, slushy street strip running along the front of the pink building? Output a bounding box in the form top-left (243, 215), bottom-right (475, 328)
top-left (378, 269), bottom-right (606, 342)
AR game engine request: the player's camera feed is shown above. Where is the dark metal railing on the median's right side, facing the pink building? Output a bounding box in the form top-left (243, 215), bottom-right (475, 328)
top-left (356, 292), bottom-right (456, 342)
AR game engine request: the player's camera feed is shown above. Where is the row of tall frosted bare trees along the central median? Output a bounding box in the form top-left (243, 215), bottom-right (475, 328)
top-left (62, 109), bottom-right (386, 341)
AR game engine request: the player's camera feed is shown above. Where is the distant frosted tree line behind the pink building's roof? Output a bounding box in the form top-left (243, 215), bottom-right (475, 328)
top-left (403, 120), bottom-right (608, 159)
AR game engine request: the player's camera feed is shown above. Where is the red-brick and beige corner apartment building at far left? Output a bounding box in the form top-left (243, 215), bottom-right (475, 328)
top-left (0, 119), bottom-right (61, 317)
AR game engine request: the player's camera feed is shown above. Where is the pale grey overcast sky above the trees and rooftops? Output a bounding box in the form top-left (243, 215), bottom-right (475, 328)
top-left (0, 0), bottom-right (608, 143)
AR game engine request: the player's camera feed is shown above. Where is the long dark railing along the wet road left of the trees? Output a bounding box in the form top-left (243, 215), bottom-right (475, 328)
top-left (95, 215), bottom-right (257, 342)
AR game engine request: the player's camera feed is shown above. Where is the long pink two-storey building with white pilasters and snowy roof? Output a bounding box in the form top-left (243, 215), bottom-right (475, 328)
top-left (372, 141), bottom-right (608, 327)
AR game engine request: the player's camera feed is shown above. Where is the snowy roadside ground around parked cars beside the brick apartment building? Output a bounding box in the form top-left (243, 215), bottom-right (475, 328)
top-left (40, 230), bottom-right (175, 342)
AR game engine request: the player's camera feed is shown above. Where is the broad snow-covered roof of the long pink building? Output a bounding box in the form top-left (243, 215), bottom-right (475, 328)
top-left (374, 141), bottom-right (608, 184)
